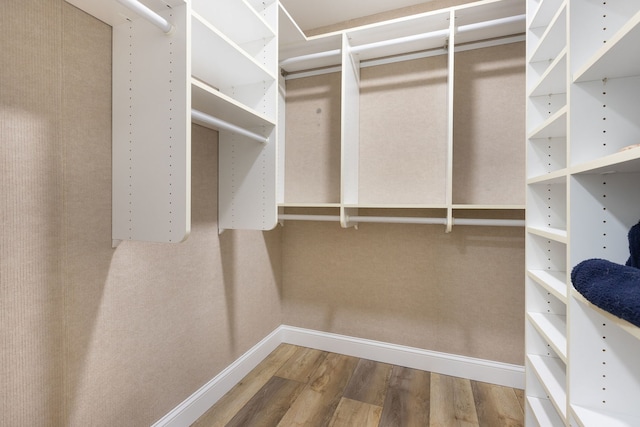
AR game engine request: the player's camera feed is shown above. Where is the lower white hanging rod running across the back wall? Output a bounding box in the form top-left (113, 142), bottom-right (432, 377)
top-left (278, 214), bottom-right (525, 227)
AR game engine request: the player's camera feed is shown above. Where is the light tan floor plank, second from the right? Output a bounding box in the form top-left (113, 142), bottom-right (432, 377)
top-left (429, 374), bottom-right (478, 427)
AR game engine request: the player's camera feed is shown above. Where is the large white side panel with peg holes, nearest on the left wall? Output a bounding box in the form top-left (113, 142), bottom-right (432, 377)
top-left (112, 5), bottom-right (191, 242)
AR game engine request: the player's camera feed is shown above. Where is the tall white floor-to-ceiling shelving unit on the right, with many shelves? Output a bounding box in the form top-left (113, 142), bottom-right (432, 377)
top-left (526, 0), bottom-right (640, 427)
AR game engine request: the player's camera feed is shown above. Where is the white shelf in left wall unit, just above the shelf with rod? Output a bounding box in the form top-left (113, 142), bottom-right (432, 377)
top-left (191, 13), bottom-right (277, 89)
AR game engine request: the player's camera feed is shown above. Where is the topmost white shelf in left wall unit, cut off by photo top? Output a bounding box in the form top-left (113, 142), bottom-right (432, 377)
top-left (191, 0), bottom-right (276, 45)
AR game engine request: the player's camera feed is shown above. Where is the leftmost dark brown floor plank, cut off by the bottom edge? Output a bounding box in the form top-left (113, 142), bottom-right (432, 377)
top-left (225, 377), bottom-right (305, 427)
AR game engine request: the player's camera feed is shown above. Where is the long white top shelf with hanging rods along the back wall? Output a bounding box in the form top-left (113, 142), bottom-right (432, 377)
top-left (279, 0), bottom-right (525, 72)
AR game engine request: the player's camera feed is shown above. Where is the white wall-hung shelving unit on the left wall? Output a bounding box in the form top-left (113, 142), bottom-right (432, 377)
top-left (68, 0), bottom-right (279, 242)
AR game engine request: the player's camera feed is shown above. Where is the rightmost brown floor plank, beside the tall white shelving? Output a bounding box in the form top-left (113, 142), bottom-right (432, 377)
top-left (471, 381), bottom-right (524, 427)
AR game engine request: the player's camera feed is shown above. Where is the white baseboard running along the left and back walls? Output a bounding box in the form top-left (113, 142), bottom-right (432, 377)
top-left (152, 325), bottom-right (524, 427)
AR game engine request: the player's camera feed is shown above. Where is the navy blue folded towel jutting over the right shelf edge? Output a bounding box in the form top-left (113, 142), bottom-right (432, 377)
top-left (571, 259), bottom-right (640, 326)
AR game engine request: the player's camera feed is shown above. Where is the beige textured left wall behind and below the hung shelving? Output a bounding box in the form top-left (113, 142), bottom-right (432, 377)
top-left (0, 0), bottom-right (281, 426)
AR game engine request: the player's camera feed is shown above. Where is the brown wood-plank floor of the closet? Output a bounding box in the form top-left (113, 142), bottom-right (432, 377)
top-left (193, 344), bottom-right (524, 427)
